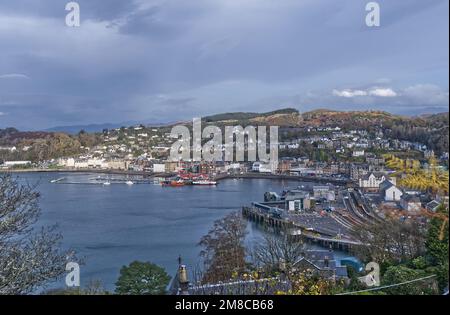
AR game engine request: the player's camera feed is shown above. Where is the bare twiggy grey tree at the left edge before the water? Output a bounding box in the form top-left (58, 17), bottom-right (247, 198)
top-left (0, 174), bottom-right (76, 294)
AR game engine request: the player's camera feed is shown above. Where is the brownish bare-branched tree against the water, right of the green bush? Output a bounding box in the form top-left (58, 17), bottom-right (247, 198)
top-left (199, 212), bottom-right (247, 283)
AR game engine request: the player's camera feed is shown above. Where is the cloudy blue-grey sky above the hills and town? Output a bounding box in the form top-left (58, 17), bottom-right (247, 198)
top-left (0, 0), bottom-right (449, 130)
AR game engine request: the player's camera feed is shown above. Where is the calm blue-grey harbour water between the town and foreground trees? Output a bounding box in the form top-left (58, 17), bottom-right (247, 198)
top-left (11, 173), bottom-right (352, 290)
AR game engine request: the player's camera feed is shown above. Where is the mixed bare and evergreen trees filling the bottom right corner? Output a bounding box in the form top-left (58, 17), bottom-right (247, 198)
top-left (354, 206), bottom-right (449, 295)
